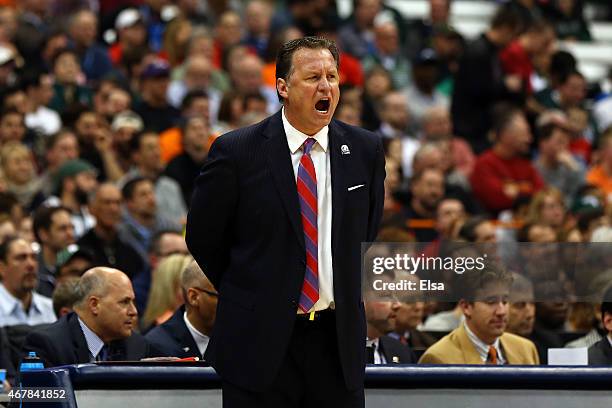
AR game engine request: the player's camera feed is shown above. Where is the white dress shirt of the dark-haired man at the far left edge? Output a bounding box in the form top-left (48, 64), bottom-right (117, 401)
top-left (0, 283), bottom-right (57, 326)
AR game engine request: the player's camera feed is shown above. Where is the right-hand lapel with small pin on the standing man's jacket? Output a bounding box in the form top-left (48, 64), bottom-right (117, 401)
top-left (329, 121), bottom-right (351, 262)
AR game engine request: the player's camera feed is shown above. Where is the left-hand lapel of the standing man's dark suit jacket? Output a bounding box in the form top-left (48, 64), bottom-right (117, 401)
top-left (264, 111), bottom-right (305, 248)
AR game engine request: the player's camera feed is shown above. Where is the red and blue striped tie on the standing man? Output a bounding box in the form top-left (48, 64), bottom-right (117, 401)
top-left (297, 137), bottom-right (319, 313)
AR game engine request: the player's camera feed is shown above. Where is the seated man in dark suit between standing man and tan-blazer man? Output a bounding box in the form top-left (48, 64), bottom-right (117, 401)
top-left (364, 292), bottom-right (416, 364)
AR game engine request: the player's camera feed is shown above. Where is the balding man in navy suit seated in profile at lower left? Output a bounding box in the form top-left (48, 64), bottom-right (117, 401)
top-left (23, 267), bottom-right (155, 367)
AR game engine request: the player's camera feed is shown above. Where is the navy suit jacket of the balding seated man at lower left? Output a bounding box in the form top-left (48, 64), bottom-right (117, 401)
top-left (22, 312), bottom-right (159, 367)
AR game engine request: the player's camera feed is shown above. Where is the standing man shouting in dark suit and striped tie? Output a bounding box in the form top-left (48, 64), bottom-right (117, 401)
top-left (186, 37), bottom-right (385, 408)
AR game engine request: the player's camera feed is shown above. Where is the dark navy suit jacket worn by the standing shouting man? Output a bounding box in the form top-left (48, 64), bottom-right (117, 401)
top-left (186, 111), bottom-right (385, 391)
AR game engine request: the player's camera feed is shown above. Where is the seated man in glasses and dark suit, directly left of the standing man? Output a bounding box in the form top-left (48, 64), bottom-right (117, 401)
top-left (146, 261), bottom-right (218, 359)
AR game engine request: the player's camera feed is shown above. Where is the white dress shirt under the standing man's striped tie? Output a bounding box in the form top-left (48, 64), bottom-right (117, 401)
top-left (282, 108), bottom-right (334, 313)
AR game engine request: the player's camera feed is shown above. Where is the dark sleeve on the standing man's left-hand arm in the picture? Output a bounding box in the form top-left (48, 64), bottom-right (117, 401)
top-left (185, 137), bottom-right (238, 288)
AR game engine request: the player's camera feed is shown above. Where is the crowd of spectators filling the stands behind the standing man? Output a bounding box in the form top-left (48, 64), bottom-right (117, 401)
top-left (0, 0), bottom-right (612, 392)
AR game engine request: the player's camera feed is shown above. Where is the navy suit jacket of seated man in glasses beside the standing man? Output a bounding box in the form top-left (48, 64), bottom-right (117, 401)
top-left (145, 306), bottom-right (202, 358)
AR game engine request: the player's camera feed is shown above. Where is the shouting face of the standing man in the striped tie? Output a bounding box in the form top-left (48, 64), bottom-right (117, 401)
top-left (276, 48), bottom-right (340, 135)
